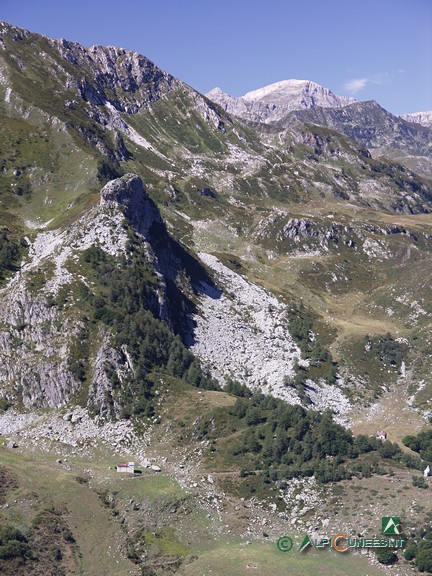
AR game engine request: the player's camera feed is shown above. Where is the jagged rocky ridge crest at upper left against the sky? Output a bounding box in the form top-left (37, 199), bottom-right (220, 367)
top-left (0, 21), bottom-right (230, 162)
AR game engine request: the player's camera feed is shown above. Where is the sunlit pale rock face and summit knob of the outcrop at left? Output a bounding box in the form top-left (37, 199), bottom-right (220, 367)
top-left (0, 174), bottom-right (167, 412)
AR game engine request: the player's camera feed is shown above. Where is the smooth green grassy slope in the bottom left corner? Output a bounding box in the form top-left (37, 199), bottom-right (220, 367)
top-left (0, 448), bottom-right (138, 576)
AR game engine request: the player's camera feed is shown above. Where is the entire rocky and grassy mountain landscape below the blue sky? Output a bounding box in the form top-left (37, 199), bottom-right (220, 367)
top-left (0, 22), bottom-right (432, 576)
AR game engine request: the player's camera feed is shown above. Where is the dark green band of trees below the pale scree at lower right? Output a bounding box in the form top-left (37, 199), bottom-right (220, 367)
top-left (195, 381), bottom-right (423, 484)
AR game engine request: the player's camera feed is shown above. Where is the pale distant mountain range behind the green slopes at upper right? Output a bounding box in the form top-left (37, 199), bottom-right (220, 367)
top-left (206, 80), bottom-right (432, 176)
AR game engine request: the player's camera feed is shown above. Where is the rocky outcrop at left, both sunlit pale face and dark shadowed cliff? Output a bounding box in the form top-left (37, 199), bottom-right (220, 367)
top-left (0, 174), bottom-right (218, 410)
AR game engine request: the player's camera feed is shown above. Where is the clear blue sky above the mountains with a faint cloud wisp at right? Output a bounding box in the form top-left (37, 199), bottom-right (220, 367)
top-left (0, 0), bottom-right (432, 114)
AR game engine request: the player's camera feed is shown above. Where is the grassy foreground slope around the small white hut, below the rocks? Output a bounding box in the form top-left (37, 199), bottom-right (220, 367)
top-left (0, 380), bottom-right (429, 576)
